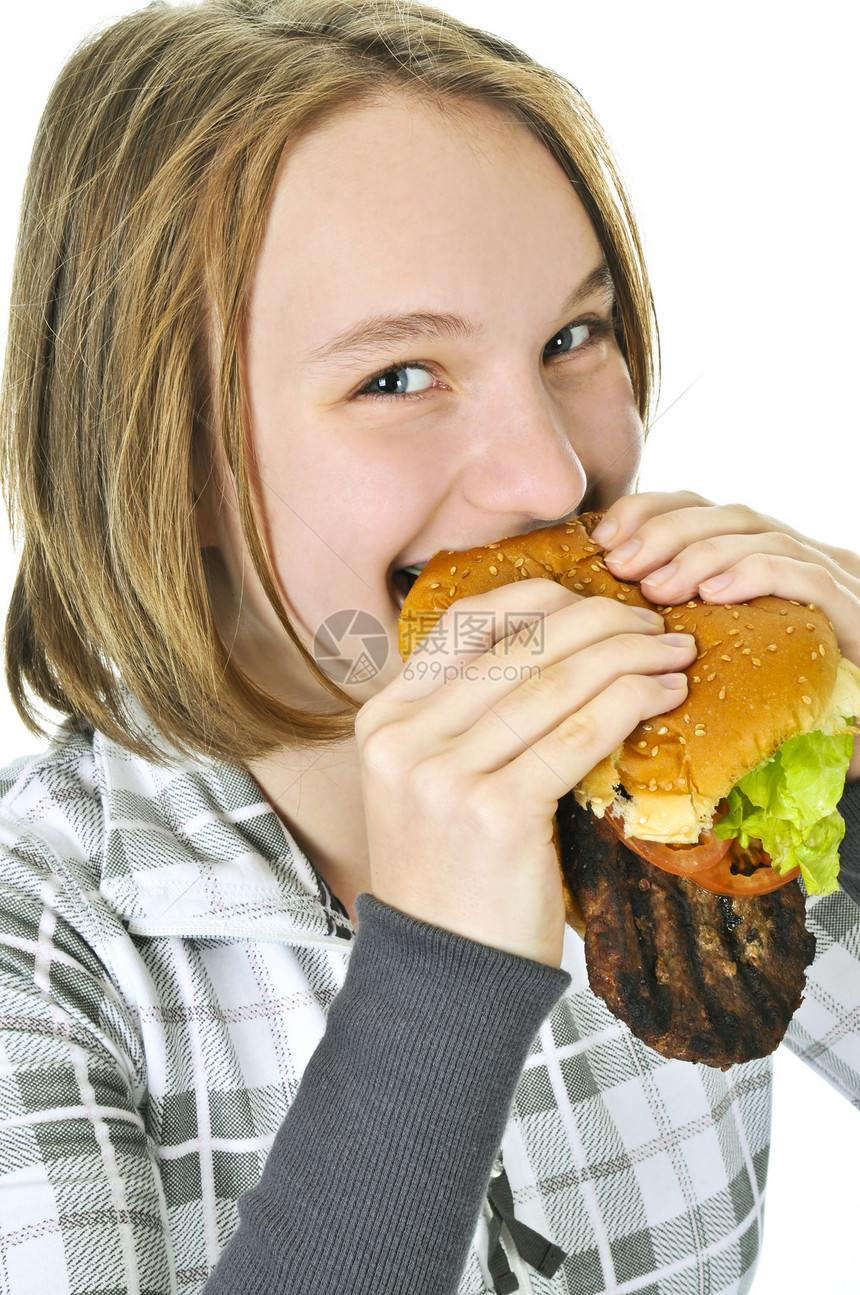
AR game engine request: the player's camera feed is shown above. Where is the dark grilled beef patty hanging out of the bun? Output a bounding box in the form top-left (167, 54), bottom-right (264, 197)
top-left (558, 793), bottom-right (815, 1067)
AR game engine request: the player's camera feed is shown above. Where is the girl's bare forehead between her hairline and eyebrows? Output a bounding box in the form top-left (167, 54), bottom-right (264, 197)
top-left (244, 95), bottom-right (600, 333)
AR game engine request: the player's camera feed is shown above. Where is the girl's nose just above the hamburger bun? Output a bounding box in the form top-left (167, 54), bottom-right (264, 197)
top-left (461, 383), bottom-right (587, 524)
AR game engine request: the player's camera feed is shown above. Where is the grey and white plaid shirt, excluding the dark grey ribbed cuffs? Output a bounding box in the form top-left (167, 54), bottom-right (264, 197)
top-left (0, 732), bottom-right (860, 1295)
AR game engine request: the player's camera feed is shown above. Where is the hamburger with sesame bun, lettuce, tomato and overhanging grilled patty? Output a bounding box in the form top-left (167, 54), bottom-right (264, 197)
top-left (399, 513), bottom-right (860, 1066)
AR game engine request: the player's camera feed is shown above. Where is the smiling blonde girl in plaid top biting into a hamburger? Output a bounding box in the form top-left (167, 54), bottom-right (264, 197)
top-left (1, 0), bottom-right (860, 1295)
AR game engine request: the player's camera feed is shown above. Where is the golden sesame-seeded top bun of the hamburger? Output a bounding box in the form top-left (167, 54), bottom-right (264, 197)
top-left (399, 513), bottom-right (839, 843)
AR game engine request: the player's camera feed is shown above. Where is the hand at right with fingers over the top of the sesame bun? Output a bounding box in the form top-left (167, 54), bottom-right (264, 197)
top-left (593, 492), bottom-right (860, 778)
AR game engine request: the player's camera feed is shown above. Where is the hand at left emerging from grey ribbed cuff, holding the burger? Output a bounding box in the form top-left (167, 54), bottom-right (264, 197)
top-left (355, 579), bottom-right (696, 966)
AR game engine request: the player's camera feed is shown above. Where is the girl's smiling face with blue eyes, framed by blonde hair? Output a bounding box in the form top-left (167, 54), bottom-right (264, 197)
top-left (204, 96), bottom-right (641, 708)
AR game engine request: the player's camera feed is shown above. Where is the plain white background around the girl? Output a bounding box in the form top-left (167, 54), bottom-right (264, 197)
top-left (0, 0), bottom-right (860, 1295)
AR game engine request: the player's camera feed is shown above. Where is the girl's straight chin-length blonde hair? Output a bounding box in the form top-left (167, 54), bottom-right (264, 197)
top-left (1, 0), bottom-right (657, 760)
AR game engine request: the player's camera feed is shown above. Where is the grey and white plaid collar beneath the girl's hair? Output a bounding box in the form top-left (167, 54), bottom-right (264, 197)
top-left (93, 714), bottom-right (354, 945)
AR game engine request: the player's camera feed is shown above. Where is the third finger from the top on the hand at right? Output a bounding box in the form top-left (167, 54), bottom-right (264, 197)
top-left (640, 531), bottom-right (860, 603)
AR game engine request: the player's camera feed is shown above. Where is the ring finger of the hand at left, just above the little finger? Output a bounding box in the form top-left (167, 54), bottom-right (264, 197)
top-left (450, 633), bottom-right (697, 773)
